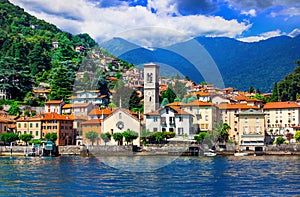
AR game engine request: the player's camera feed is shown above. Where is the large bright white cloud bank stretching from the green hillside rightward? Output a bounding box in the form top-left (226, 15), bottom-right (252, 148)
top-left (11, 0), bottom-right (253, 47)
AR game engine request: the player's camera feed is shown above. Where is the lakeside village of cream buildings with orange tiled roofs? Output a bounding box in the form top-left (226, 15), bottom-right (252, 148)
top-left (0, 63), bottom-right (300, 155)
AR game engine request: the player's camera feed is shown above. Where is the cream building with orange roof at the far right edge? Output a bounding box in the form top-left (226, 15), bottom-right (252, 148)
top-left (263, 101), bottom-right (300, 142)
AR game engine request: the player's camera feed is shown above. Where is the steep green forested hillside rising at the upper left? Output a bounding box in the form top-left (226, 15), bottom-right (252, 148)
top-left (0, 0), bottom-right (97, 100)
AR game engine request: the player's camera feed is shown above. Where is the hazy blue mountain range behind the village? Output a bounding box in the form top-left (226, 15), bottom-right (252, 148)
top-left (101, 36), bottom-right (300, 92)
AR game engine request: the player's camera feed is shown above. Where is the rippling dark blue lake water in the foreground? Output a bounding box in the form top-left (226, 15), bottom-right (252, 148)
top-left (0, 156), bottom-right (300, 196)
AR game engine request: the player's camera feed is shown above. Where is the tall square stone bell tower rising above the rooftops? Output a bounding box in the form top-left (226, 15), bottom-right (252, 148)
top-left (144, 63), bottom-right (159, 114)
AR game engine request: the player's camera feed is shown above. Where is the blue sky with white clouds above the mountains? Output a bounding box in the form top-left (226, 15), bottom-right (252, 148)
top-left (10, 0), bottom-right (300, 47)
